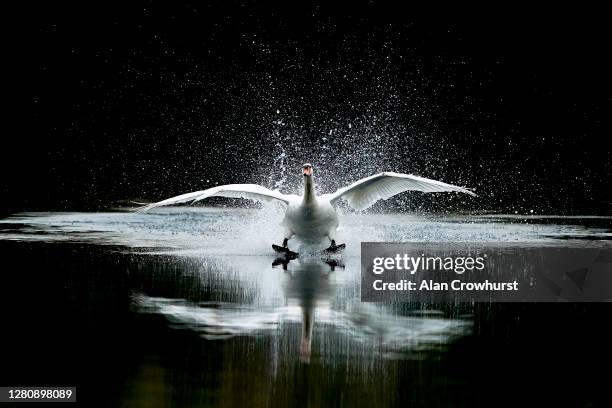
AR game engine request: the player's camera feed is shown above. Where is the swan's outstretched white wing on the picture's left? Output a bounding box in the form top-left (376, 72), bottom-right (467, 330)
top-left (137, 184), bottom-right (290, 212)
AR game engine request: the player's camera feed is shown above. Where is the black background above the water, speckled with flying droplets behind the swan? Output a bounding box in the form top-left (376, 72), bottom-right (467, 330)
top-left (0, 2), bottom-right (612, 214)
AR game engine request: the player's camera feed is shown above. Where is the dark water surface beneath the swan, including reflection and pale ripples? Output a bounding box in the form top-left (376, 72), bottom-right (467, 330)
top-left (0, 211), bottom-right (612, 407)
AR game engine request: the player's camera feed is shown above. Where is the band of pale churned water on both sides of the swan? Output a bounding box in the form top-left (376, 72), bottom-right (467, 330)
top-left (0, 210), bottom-right (612, 252)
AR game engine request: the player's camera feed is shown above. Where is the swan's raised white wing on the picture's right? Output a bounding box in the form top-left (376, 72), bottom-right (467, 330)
top-left (330, 172), bottom-right (476, 210)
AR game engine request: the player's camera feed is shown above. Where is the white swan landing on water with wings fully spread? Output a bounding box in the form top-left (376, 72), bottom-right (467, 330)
top-left (138, 163), bottom-right (476, 252)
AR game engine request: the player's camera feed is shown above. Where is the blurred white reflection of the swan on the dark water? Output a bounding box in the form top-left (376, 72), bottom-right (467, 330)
top-left (132, 257), bottom-right (472, 363)
